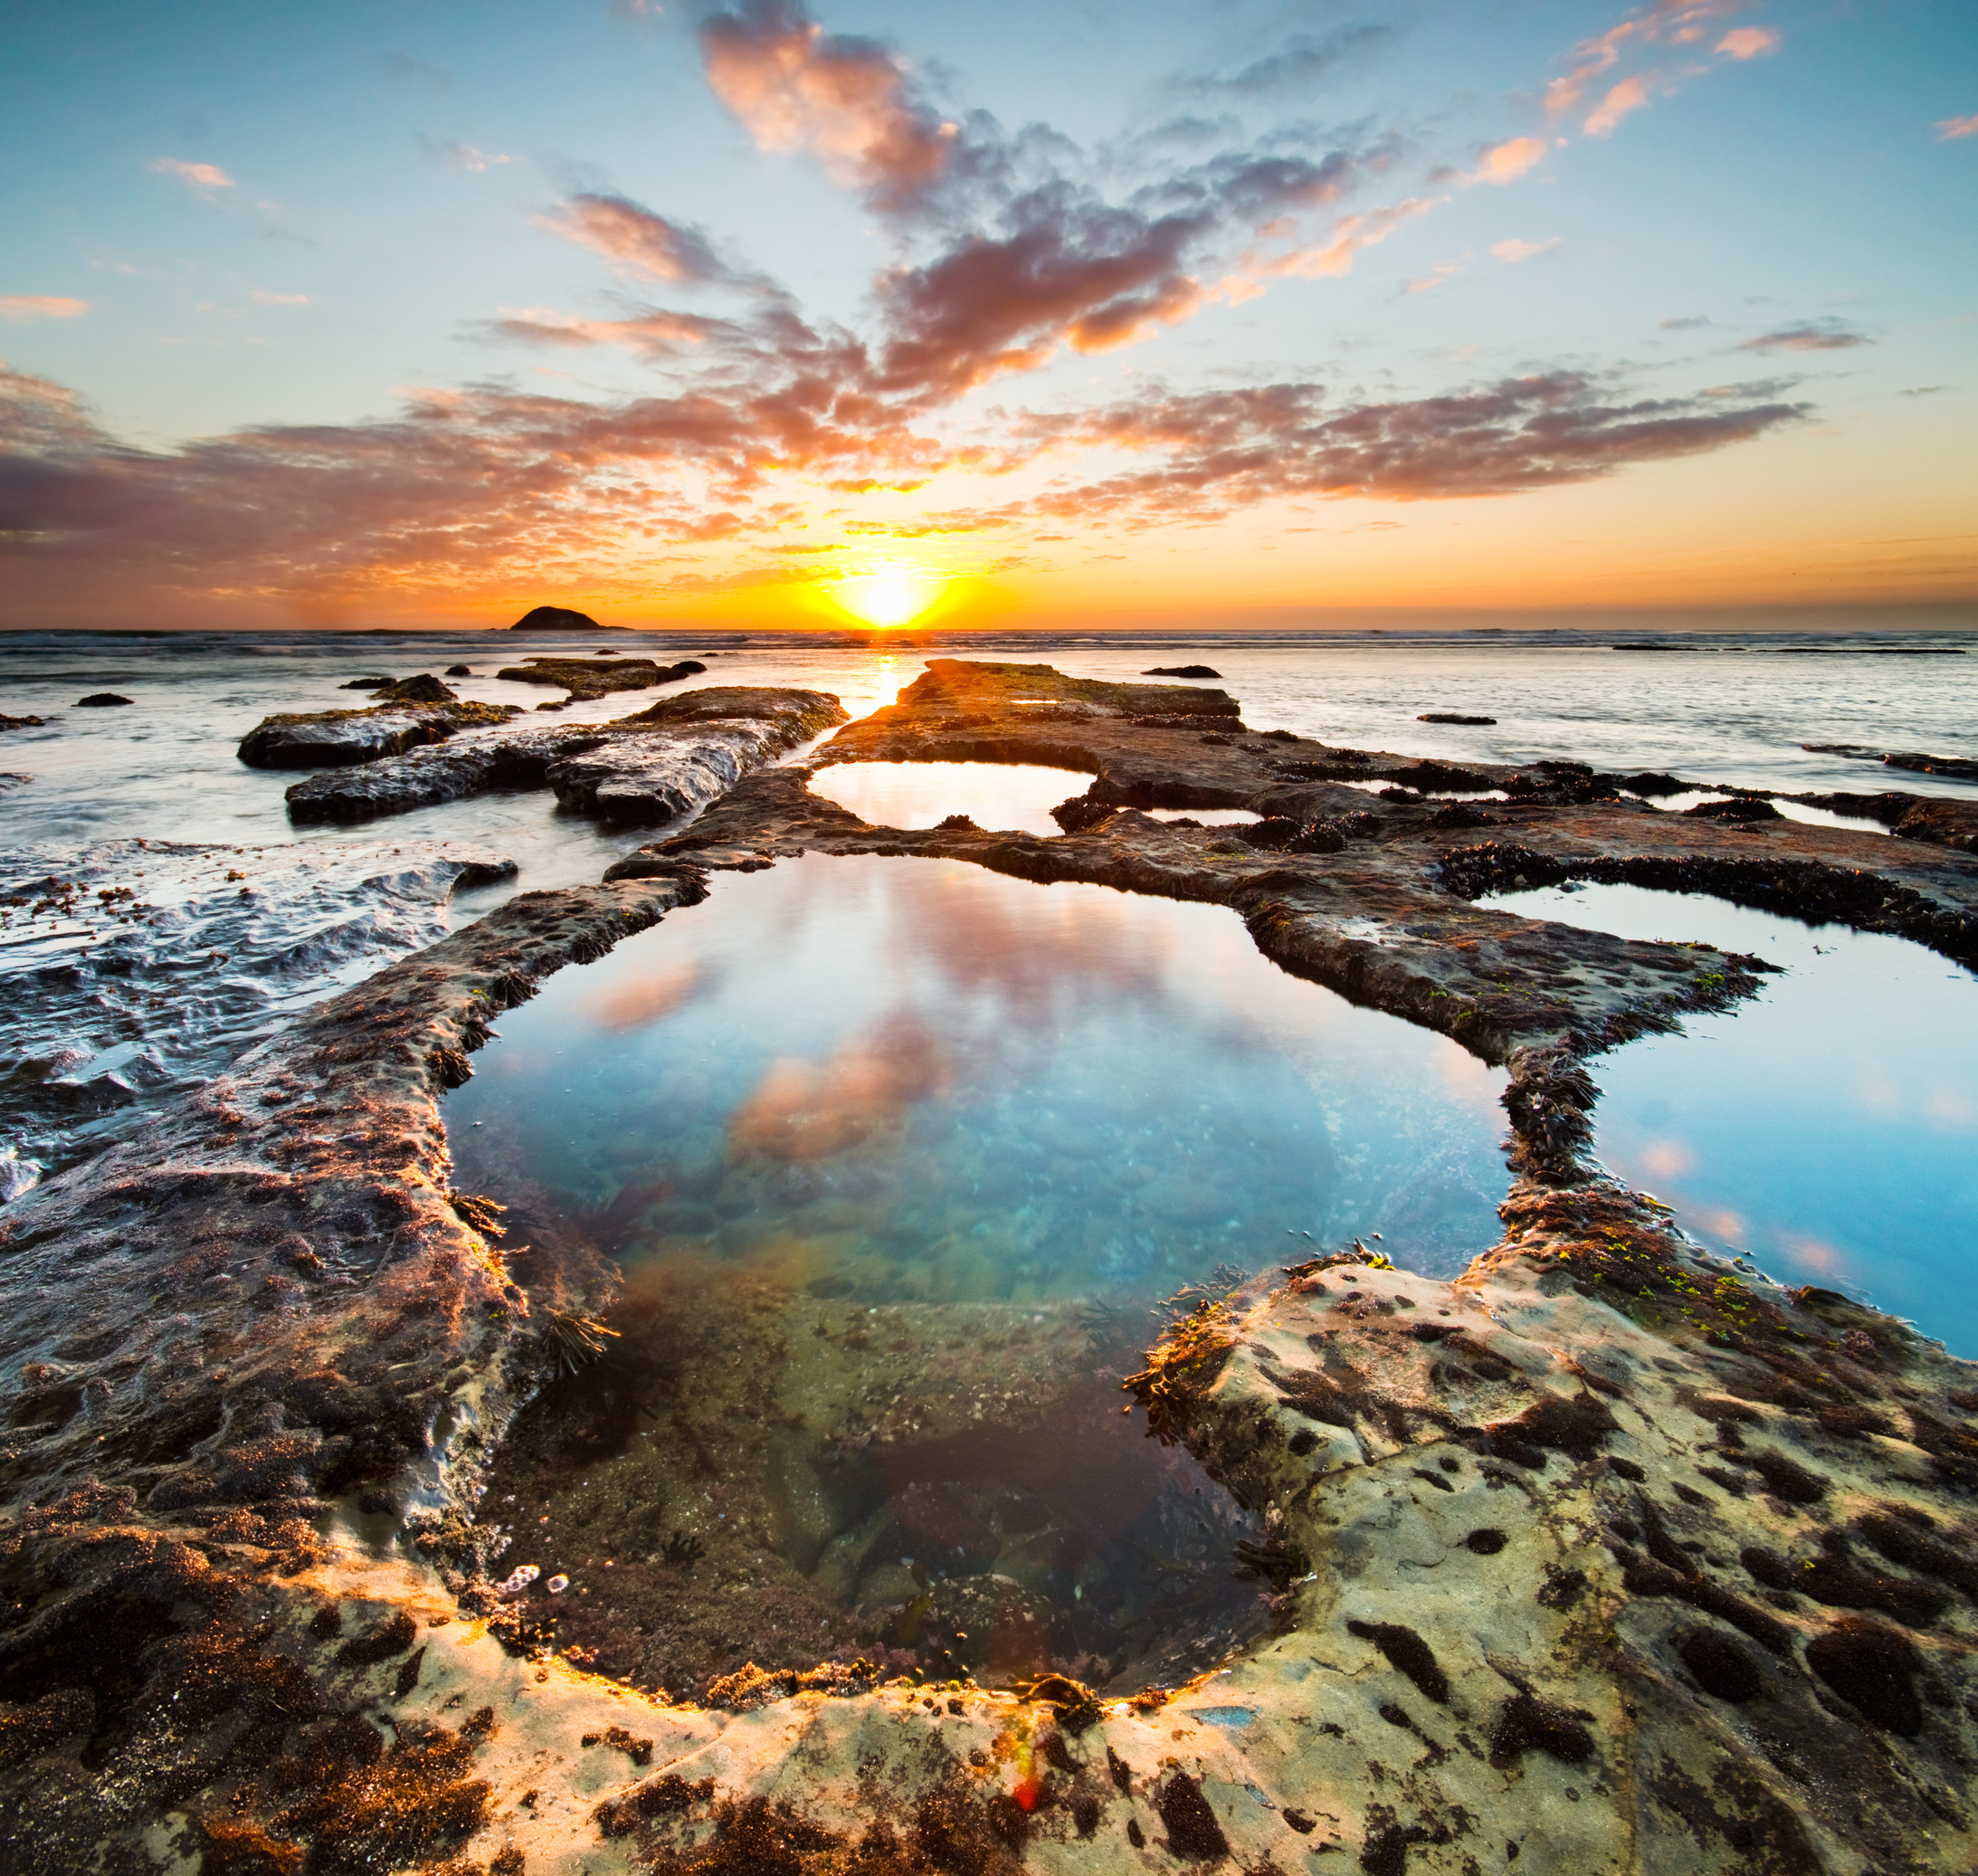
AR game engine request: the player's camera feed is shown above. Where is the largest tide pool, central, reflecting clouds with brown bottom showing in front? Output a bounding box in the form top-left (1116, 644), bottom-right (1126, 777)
top-left (447, 855), bottom-right (1506, 1694)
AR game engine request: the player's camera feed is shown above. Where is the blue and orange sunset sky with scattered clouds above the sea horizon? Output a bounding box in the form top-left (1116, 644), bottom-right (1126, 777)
top-left (0, 0), bottom-right (1978, 627)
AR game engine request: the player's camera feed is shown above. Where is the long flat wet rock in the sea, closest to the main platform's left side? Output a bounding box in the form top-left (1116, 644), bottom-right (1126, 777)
top-left (287, 685), bottom-right (847, 825)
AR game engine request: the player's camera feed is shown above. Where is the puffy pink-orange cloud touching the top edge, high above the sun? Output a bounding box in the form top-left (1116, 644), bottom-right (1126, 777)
top-left (700, 0), bottom-right (957, 210)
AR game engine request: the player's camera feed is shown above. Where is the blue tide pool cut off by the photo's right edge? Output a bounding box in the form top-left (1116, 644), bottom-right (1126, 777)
top-left (1488, 884), bottom-right (1978, 1356)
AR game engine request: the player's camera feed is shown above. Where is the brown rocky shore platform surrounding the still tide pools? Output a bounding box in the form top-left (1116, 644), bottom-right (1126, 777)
top-left (0, 661), bottom-right (1978, 1876)
